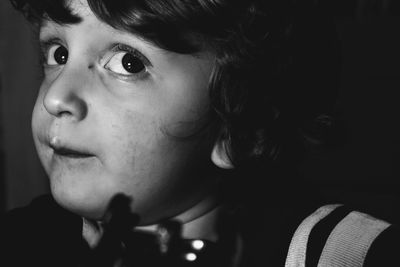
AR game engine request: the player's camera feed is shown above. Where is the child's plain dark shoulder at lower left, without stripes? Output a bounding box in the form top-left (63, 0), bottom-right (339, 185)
top-left (0, 195), bottom-right (82, 266)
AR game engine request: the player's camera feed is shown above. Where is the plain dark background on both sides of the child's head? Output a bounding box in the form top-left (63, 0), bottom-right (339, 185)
top-left (0, 0), bottom-right (400, 217)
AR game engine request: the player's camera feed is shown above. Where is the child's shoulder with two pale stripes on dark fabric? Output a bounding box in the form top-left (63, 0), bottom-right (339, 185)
top-left (286, 205), bottom-right (400, 267)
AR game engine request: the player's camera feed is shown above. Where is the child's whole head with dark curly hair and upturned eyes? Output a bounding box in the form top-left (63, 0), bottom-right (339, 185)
top-left (10, 0), bottom-right (340, 224)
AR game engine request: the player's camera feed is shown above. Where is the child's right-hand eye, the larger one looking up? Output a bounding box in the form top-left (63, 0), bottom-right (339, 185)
top-left (104, 45), bottom-right (150, 76)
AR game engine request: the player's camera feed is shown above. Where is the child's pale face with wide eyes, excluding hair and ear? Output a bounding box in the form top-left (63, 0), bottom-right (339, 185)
top-left (32, 1), bottom-right (217, 223)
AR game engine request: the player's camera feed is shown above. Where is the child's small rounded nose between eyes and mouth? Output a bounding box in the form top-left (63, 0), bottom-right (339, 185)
top-left (43, 66), bottom-right (88, 121)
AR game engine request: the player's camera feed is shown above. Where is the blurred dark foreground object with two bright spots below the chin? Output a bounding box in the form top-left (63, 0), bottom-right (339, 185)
top-left (83, 194), bottom-right (224, 267)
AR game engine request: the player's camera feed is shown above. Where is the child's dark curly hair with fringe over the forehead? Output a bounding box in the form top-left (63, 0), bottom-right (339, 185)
top-left (11, 0), bottom-right (340, 171)
